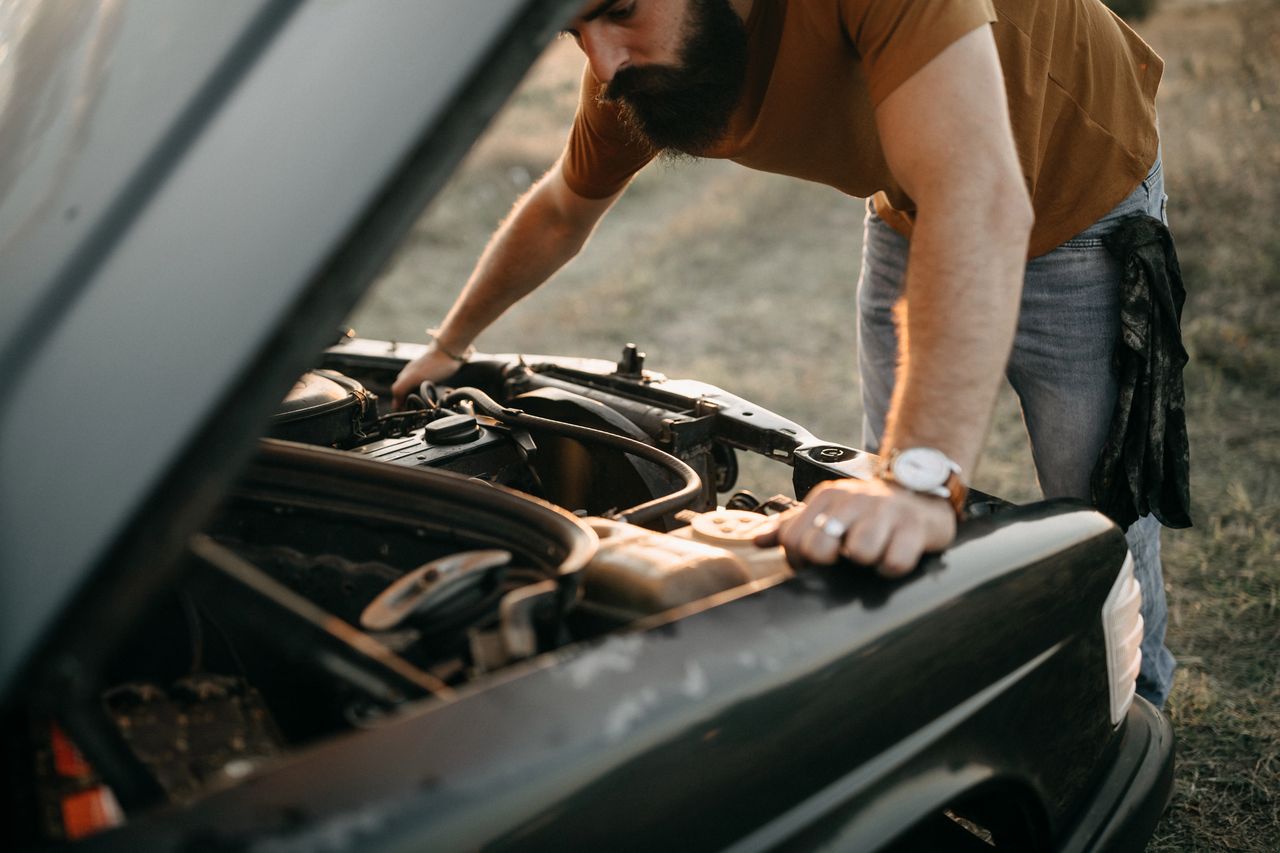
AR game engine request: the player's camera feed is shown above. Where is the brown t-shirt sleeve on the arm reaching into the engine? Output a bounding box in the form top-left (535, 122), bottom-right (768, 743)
top-left (561, 67), bottom-right (653, 199)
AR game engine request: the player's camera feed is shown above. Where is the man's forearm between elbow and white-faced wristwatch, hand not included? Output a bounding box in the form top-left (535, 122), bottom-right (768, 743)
top-left (882, 177), bottom-right (1032, 473)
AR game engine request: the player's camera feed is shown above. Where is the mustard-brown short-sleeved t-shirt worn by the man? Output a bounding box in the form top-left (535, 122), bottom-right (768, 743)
top-left (564, 0), bottom-right (1164, 257)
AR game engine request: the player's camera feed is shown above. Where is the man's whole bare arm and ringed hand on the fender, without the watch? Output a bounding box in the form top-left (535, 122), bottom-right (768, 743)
top-left (760, 28), bottom-right (1033, 575)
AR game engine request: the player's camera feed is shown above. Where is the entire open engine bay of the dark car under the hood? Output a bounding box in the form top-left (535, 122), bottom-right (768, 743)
top-left (15, 347), bottom-right (859, 840)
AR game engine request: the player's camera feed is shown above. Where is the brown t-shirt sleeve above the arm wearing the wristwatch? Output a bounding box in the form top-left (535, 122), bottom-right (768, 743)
top-left (837, 0), bottom-right (996, 106)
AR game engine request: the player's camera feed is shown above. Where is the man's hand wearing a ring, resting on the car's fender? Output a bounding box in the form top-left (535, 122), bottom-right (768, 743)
top-left (755, 480), bottom-right (956, 578)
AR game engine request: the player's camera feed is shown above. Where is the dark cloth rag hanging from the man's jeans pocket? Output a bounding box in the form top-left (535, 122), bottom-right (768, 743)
top-left (1091, 214), bottom-right (1192, 529)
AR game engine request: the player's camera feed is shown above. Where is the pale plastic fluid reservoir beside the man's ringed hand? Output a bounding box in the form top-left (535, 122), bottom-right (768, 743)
top-left (584, 510), bottom-right (791, 615)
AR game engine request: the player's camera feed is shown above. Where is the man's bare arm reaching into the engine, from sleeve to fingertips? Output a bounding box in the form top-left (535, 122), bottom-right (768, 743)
top-left (392, 161), bottom-right (622, 405)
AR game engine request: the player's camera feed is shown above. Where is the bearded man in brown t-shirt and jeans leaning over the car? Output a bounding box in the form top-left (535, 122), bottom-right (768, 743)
top-left (393, 0), bottom-right (1172, 704)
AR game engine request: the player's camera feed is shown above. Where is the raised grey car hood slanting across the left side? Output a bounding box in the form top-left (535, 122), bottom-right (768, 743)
top-left (0, 0), bottom-right (575, 697)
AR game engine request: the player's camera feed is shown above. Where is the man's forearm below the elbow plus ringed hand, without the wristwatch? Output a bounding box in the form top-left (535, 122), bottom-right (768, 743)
top-left (756, 185), bottom-right (1032, 578)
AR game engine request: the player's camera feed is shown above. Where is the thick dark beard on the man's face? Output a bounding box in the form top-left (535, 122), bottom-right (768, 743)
top-left (600, 0), bottom-right (748, 154)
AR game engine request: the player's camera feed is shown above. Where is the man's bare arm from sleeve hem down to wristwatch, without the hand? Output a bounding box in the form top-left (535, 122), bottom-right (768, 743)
top-left (876, 28), bottom-right (1033, 471)
